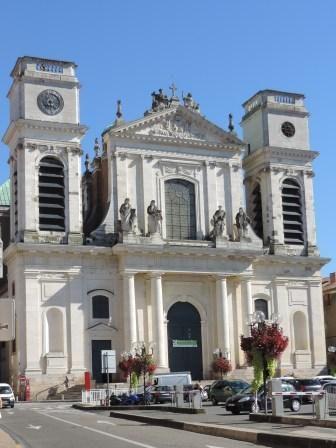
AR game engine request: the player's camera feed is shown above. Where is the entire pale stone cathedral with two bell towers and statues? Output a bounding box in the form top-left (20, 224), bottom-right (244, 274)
top-left (0, 57), bottom-right (327, 393)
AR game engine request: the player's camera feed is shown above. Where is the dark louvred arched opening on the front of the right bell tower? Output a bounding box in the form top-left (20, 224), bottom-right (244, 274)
top-left (282, 179), bottom-right (303, 244)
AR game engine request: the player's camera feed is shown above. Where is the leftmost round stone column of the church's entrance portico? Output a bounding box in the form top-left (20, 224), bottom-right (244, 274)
top-left (122, 272), bottom-right (137, 351)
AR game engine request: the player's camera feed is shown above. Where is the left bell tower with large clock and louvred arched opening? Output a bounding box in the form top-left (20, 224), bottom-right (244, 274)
top-left (3, 56), bottom-right (86, 244)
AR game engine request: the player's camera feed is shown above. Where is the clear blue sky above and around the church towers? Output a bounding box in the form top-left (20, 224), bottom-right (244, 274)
top-left (0, 0), bottom-right (336, 275)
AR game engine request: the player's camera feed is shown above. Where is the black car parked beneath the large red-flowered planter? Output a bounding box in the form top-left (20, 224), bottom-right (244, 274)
top-left (225, 381), bottom-right (301, 414)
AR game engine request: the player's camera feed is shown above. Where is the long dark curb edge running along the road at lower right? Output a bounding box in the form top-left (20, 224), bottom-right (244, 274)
top-left (110, 411), bottom-right (336, 448)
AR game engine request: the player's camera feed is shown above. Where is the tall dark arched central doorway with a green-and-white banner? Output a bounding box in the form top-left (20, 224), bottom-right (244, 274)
top-left (167, 302), bottom-right (203, 380)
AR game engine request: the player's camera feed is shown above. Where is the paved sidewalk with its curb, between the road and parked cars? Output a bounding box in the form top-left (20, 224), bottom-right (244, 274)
top-left (103, 408), bottom-right (336, 448)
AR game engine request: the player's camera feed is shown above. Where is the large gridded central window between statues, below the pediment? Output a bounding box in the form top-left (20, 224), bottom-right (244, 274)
top-left (165, 179), bottom-right (196, 240)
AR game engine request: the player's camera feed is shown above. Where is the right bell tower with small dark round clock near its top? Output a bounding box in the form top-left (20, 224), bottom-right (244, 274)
top-left (242, 90), bottom-right (318, 255)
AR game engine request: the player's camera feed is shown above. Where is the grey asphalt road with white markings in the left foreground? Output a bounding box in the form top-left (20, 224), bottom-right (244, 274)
top-left (0, 403), bottom-right (270, 448)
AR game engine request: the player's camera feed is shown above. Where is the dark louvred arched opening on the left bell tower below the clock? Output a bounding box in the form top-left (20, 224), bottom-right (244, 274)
top-left (39, 157), bottom-right (65, 231)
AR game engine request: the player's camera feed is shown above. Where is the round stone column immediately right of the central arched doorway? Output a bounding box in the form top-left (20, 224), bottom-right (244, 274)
top-left (216, 277), bottom-right (230, 353)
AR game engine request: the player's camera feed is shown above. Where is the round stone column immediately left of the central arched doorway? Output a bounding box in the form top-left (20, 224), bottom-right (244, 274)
top-left (150, 273), bottom-right (168, 369)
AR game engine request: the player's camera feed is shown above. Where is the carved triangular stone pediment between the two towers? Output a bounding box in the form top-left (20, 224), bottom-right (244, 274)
top-left (110, 106), bottom-right (244, 146)
